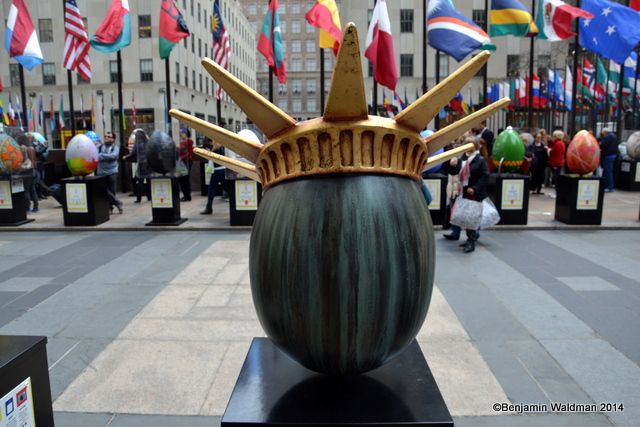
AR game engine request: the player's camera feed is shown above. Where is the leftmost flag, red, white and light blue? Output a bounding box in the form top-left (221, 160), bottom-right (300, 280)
top-left (4, 0), bottom-right (44, 70)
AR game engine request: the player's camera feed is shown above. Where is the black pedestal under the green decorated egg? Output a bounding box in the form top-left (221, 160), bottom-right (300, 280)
top-left (487, 173), bottom-right (531, 225)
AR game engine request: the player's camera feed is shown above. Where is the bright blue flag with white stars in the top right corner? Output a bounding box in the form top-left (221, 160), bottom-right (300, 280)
top-left (579, 0), bottom-right (640, 64)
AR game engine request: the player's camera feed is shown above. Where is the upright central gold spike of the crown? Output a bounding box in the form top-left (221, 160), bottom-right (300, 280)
top-left (324, 22), bottom-right (368, 121)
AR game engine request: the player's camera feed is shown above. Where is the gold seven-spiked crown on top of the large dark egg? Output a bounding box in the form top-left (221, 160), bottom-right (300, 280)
top-left (170, 23), bottom-right (509, 188)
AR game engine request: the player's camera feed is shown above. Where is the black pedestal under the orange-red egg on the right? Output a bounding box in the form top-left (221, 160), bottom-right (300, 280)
top-left (555, 175), bottom-right (604, 225)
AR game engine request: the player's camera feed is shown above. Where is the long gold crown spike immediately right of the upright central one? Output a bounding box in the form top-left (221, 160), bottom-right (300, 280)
top-left (395, 50), bottom-right (491, 132)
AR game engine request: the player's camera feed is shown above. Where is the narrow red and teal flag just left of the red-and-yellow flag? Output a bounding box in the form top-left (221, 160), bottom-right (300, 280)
top-left (258, 0), bottom-right (287, 84)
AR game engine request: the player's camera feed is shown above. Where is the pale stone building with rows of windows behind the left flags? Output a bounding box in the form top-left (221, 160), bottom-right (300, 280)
top-left (0, 0), bottom-right (256, 146)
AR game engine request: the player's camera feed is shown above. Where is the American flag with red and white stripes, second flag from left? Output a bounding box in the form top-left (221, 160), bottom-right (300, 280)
top-left (63, 0), bottom-right (91, 80)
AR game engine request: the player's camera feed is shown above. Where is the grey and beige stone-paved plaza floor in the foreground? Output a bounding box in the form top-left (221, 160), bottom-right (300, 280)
top-left (0, 230), bottom-right (640, 427)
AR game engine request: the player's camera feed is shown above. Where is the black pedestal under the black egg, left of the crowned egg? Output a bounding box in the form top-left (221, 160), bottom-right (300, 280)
top-left (145, 176), bottom-right (187, 225)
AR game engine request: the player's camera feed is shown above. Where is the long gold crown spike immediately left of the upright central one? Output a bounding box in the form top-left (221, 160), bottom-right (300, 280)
top-left (202, 58), bottom-right (296, 138)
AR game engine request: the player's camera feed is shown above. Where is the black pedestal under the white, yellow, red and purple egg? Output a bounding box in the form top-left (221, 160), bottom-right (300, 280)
top-left (62, 176), bottom-right (109, 227)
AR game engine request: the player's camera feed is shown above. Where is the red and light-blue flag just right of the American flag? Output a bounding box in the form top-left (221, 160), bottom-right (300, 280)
top-left (90, 0), bottom-right (131, 53)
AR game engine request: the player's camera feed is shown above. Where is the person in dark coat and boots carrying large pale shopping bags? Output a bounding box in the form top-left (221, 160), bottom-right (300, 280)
top-left (444, 138), bottom-right (489, 253)
